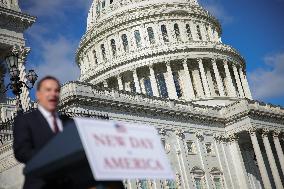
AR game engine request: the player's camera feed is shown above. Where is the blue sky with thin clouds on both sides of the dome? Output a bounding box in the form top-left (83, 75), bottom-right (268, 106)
top-left (17, 0), bottom-right (284, 106)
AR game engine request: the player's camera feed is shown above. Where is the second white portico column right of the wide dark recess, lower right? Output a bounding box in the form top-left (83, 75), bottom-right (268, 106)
top-left (262, 130), bottom-right (283, 189)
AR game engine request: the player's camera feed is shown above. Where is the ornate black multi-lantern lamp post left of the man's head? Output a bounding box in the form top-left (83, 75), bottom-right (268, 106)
top-left (2, 52), bottom-right (38, 113)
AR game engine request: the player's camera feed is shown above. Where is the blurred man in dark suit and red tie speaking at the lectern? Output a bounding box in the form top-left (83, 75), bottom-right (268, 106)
top-left (13, 76), bottom-right (69, 189)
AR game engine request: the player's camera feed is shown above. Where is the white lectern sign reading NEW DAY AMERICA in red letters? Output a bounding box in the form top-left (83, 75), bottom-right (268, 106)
top-left (75, 118), bottom-right (174, 180)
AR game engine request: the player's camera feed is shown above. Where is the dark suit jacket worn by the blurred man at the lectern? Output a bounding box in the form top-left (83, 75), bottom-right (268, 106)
top-left (13, 109), bottom-right (71, 189)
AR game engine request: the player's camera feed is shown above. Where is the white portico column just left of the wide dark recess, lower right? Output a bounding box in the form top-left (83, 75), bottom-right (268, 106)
top-left (229, 134), bottom-right (250, 189)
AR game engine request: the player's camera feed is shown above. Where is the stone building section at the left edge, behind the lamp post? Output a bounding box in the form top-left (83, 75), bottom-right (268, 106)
top-left (0, 0), bottom-right (35, 189)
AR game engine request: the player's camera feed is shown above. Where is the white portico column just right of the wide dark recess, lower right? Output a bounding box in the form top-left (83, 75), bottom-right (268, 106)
top-left (249, 128), bottom-right (272, 189)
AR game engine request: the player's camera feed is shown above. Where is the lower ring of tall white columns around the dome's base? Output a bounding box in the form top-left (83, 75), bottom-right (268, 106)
top-left (103, 58), bottom-right (252, 101)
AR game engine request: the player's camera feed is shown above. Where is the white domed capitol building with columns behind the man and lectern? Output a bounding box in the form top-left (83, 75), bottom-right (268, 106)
top-left (0, 0), bottom-right (284, 189)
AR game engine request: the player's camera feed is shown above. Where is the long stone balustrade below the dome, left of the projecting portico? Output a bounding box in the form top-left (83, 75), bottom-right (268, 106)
top-left (60, 82), bottom-right (221, 119)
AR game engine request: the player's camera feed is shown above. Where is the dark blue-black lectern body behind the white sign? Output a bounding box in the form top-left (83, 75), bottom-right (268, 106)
top-left (24, 121), bottom-right (124, 189)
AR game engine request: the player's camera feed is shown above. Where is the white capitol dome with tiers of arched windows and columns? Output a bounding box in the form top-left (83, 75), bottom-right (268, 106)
top-left (76, 0), bottom-right (252, 101)
